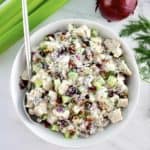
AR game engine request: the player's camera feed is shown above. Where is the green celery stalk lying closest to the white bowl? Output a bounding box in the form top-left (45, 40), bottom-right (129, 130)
top-left (0, 0), bottom-right (69, 53)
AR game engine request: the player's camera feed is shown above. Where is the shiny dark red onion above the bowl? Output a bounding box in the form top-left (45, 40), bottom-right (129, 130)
top-left (96, 0), bottom-right (137, 21)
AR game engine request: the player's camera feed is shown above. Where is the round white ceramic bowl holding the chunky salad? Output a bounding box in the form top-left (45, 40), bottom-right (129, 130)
top-left (10, 19), bottom-right (139, 147)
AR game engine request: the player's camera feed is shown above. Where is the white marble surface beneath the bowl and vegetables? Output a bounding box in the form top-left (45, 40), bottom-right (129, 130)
top-left (0, 0), bottom-right (150, 150)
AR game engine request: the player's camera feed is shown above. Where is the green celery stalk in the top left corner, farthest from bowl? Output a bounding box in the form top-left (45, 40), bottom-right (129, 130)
top-left (0, 0), bottom-right (32, 28)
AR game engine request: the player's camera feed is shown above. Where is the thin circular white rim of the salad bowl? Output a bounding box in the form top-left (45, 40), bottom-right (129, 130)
top-left (10, 18), bottom-right (140, 148)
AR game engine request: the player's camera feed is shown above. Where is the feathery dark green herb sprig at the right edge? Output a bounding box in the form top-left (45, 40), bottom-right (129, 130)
top-left (120, 16), bottom-right (150, 82)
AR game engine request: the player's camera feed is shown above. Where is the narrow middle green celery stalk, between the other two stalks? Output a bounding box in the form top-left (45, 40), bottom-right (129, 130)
top-left (0, 0), bottom-right (45, 35)
